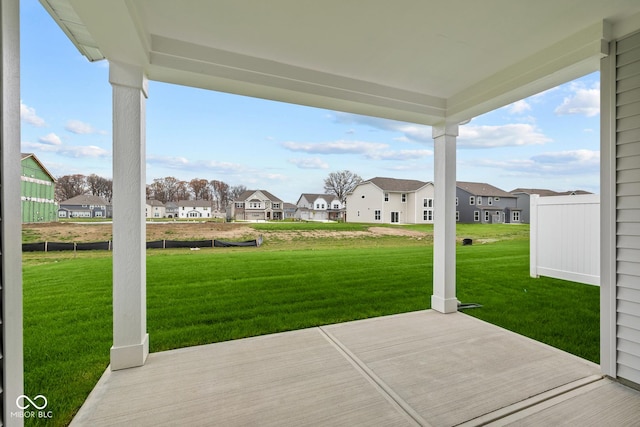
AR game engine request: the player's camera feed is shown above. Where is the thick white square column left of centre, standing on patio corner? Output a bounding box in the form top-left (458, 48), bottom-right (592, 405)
top-left (109, 62), bottom-right (149, 370)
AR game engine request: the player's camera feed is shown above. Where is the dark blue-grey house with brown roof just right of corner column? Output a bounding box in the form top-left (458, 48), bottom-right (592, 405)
top-left (456, 181), bottom-right (522, 224)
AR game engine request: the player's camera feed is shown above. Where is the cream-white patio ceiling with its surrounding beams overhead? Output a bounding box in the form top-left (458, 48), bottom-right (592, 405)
top-left (40, 0), bottom-right (640, 125)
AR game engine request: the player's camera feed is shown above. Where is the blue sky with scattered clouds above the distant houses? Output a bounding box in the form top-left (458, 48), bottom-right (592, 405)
top-left (21, 0), bottom-right (600, 203)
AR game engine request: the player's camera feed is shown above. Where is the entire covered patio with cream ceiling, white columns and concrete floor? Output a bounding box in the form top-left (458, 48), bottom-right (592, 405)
top-left (0, 0), bottom-right (640, 426)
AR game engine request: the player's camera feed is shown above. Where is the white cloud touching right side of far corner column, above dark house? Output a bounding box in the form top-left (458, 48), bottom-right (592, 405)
top-left (458, 123), bottom-right (551, 148)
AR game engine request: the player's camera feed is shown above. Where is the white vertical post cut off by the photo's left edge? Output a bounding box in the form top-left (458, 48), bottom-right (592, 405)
top-left (0, 0), bottom-right (24, 427)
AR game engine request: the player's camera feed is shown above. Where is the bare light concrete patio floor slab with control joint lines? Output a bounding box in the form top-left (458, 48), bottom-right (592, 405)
top-left (72, 310), bottom-right (640, 426)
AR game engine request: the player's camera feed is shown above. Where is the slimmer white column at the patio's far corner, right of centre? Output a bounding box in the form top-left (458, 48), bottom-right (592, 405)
top-left (431, 123), bottom-right (458, 313)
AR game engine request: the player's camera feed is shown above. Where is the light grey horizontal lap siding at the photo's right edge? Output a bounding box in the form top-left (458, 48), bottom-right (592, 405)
top-left (616, 28), bottom-right (640, 384)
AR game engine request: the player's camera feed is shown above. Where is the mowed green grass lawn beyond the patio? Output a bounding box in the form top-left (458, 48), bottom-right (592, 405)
top-left (23, 223), bottom-right (599, 425)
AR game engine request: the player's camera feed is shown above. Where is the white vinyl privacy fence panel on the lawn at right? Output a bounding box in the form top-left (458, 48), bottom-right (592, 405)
top-left (529, 194), bottom-right (600, 286)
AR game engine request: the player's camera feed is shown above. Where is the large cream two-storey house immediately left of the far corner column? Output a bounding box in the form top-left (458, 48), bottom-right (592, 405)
top-left (346, 177), bottom-right (434, 224)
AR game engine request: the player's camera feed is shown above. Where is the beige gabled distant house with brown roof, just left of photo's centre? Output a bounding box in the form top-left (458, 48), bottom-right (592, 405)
top-left (231, 190), bottom-right (284, 221)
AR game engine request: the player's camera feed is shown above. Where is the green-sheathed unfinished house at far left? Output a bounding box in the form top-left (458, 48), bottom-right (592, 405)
top-left (20, 153), bottom-right (58, 223)
